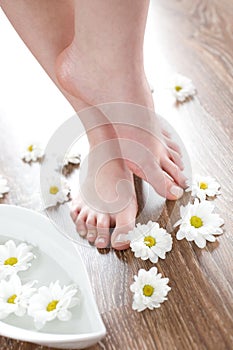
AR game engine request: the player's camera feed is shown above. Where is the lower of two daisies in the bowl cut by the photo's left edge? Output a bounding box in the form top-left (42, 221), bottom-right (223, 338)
top-left (0, 275), bottom-right (37, 319)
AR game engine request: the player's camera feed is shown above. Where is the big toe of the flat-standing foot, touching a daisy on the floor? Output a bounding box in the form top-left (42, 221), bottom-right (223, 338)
top-left (111, 204), bottom-right (137, 250)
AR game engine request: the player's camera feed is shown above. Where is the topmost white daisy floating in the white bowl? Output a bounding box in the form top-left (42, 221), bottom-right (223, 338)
top-left (0, 240), bottom-right (35, 279)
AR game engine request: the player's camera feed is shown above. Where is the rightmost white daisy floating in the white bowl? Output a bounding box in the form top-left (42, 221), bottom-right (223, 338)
top-left (28, 281), bottom-right (80, 329)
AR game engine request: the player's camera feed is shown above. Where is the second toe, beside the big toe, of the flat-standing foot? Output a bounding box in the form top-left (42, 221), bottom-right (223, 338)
top-left (95, 214), bottom-right (110, 248)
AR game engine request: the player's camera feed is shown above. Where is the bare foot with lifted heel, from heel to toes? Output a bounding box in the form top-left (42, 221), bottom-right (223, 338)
top-left (57, 44), bottom-right (186, 200)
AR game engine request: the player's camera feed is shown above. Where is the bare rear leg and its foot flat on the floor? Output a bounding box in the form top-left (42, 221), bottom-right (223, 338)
top-left (1, 0), bottom-right (137, 249)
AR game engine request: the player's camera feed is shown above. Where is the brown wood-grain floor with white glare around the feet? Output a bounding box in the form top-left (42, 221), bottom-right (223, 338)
top-left (0, 0), bottom-right (233, 350)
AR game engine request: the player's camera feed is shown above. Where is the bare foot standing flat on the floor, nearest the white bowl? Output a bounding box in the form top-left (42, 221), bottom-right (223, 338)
top-left (71, 121), bottom-right (137, 250)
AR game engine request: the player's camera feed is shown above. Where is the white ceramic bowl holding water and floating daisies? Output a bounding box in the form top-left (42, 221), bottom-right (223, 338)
top-left (0, 205), bottom-right (106, 349)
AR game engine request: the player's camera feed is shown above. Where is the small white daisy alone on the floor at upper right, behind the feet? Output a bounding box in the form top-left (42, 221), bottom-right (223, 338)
top-left (171, 74), bottom-right (196, 102)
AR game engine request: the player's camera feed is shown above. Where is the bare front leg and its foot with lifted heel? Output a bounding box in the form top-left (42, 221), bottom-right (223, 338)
top-left (57, 0), bottom-right (186, 200)
